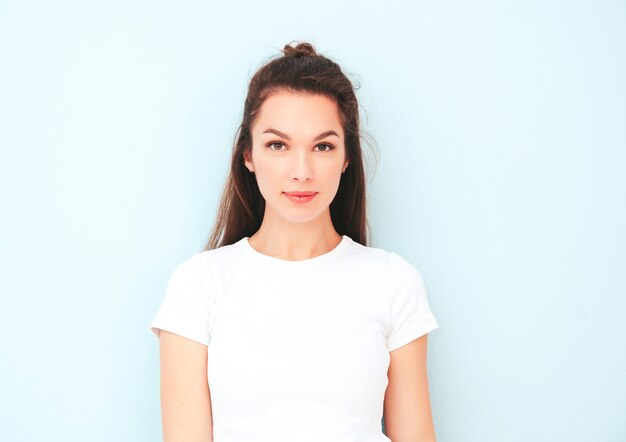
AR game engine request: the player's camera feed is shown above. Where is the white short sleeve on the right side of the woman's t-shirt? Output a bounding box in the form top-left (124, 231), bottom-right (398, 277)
top-left (387, 252), bottom-right (439, 351)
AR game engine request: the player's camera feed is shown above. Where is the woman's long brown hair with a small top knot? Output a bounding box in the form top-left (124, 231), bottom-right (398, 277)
top-left (204, 42), bottom-right (369, 250)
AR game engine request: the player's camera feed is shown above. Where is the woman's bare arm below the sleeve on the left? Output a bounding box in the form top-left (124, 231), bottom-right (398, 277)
top-left (159, 330), bottom-right (213, 442)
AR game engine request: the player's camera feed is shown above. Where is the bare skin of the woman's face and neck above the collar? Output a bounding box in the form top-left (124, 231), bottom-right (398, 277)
top-left (244, 92), bottom-right (348, 261)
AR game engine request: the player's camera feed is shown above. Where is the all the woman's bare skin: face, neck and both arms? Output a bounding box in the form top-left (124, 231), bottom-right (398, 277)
top-left (160, 92), bottom-right (435, 442)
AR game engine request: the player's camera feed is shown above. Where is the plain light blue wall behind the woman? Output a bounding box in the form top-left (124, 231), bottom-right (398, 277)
top-left (0, 0), bottom-right (626, 442)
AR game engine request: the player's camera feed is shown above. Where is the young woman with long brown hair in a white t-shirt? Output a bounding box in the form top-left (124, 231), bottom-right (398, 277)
top-left (150, 43), bottom-right (438, 442)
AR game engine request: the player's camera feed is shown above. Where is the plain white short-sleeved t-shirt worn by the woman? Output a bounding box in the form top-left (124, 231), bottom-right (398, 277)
top-left (150, 235), bottom-right (439, 442)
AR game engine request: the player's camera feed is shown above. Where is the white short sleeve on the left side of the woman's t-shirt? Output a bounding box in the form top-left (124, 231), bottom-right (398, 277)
top-left (150, 253), bottom-right (212, 345)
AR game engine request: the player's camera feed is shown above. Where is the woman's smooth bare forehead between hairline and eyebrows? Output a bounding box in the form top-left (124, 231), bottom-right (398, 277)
top-left (253, 92), bottom-right (341, 135)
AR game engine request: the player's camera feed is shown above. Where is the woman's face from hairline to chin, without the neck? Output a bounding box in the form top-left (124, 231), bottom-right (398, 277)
top-left (244, 92), bottom-right (348, 222)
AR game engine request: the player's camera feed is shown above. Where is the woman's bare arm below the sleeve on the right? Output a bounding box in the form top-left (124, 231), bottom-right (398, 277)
top-left (383, 334), bottom-right (435, 442)
